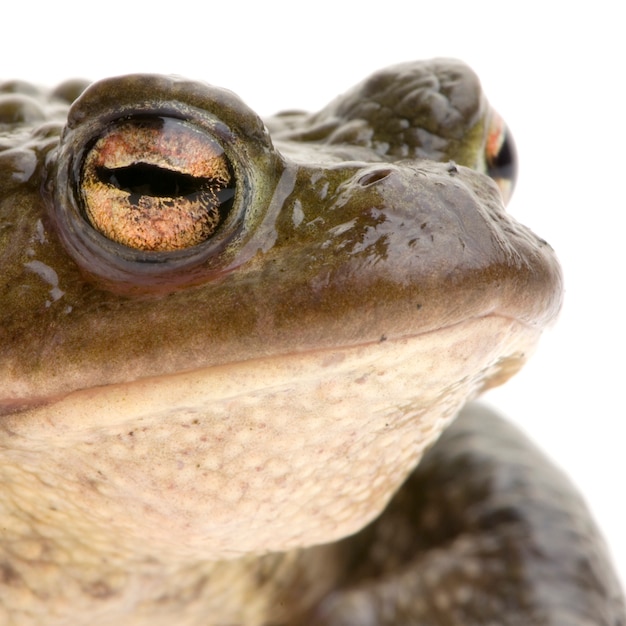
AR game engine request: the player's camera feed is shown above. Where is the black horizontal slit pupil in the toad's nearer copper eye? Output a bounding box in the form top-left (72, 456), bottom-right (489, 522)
top-left (97, 163), bottom-right (210, 198)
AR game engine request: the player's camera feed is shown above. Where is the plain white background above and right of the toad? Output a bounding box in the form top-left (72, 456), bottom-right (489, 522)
top-left (0, 0), bottom-right (626, 580)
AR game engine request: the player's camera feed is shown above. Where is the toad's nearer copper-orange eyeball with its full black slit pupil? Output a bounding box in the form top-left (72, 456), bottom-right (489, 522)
top-left (78, 116), bottom-right (235, 252)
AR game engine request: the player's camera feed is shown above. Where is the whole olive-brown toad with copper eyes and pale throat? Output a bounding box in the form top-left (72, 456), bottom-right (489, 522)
top-left (0, 60), bottom-right (626, 625)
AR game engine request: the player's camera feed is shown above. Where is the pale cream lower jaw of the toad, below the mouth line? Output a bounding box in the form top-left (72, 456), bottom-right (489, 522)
top-left (3, 315), bottom-right (539, 561)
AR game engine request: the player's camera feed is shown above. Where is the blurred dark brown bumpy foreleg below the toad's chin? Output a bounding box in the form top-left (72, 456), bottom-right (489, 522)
top-left (314, 405), bottom-right (626, 626)
